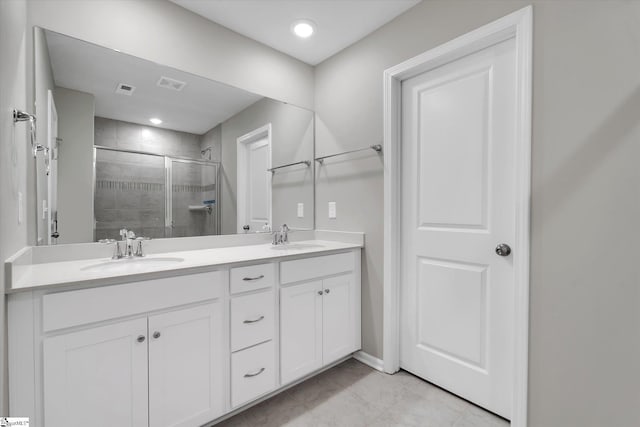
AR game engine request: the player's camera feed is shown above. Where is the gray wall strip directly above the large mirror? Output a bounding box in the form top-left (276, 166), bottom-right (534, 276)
top-left (28, 0), bottom-right (313, 108)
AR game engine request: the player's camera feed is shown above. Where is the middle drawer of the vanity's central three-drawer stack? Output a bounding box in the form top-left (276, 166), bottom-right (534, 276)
top-left (231, 290), bottom-right (275, 351)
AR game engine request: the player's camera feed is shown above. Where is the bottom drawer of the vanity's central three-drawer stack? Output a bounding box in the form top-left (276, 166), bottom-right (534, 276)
top-left (231, 341), bottom-right (277, 408)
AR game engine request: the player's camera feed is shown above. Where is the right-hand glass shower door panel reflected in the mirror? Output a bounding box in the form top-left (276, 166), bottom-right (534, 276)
top-left (167, 158), bottom-right (220, 237)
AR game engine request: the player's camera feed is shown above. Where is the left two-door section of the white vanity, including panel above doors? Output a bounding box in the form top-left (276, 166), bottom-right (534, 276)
top-left (10, 271), bottom-right (228, 427)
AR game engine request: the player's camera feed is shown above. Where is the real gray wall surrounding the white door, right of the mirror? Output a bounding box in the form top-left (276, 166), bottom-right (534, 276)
top-left (316, 0), bottom-right (640, 427)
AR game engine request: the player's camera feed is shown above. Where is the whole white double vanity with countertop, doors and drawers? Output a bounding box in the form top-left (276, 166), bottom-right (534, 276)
top-left (6, 232), bottom-right (363, 427)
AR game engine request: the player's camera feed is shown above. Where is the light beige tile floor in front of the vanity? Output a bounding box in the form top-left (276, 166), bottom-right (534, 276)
top-left (216, 359), bottom-right (509, 427)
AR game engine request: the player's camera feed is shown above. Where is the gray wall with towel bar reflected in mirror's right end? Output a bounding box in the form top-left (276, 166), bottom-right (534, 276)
top-left (220, 98), bottom-right (314, 234)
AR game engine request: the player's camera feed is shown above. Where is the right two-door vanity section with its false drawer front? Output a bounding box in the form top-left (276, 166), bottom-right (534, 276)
top-left (280, 250), bottom-right (361, 384)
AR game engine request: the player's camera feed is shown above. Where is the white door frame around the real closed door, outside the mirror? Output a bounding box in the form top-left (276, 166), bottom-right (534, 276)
top-left (383, 6), bottom-right (533, 427)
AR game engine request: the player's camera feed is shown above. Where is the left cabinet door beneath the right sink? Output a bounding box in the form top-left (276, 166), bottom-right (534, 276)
top-left (280, 281), bottom-right (322, 384)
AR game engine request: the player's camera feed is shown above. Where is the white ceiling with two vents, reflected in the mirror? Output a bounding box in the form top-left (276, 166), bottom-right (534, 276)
top-left (46, 30), bottom-right (262, 135)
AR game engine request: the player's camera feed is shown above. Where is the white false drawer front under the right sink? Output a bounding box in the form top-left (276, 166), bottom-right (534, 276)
top-left (280, 252), bottom-right (355, 284)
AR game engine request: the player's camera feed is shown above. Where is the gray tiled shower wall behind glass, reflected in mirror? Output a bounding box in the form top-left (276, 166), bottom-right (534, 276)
top-left (94, 117), bottom-right (219, 239)
